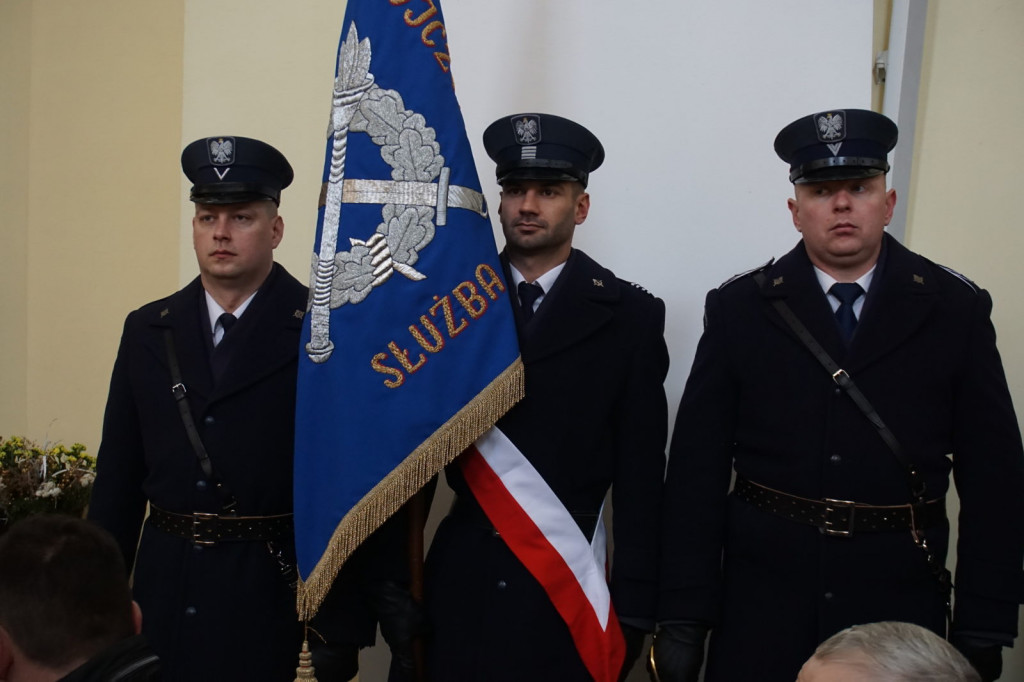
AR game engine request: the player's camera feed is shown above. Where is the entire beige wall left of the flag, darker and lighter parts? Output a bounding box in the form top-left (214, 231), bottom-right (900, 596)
top-left (0, 0), bottom-right (335, 444)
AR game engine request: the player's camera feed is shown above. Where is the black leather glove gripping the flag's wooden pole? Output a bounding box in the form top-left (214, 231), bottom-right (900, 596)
top-left (369, 581), bottom-right (426, 682)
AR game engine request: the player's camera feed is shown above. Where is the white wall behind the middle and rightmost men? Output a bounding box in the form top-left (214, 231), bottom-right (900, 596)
top-left (423, 0), bottom-right (872, 414)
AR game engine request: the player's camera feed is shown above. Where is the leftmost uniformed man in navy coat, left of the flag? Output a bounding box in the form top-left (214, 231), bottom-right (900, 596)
top-left (89, 137), bottom-right (387, 682)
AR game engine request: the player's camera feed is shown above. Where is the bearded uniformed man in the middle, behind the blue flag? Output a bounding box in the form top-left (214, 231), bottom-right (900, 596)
top-left (426, 114), bottom-right (669, 682)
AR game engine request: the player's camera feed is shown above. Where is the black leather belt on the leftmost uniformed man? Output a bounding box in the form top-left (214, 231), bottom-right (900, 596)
top-left (146, 505), bottom-right (294, 546)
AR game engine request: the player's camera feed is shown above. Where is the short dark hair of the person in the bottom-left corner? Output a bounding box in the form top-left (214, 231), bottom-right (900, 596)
top-left (0, 514), bottom-right (134, 668)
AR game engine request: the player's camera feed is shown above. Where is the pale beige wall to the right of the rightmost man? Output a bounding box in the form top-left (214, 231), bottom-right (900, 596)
top-left (907, 0), bottom-right (1024, 680)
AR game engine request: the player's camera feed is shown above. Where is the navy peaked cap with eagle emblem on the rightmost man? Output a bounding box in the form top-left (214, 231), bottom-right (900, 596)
top-left (775, 109), bottom-right (899, 184)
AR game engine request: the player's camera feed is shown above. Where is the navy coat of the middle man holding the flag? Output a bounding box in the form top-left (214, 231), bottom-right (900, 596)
top-left (426, 250), bottom-right (669, 682)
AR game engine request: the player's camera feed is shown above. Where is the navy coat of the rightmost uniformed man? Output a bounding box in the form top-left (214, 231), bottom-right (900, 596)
top-left (660, 236), bottom-right (1024, 682)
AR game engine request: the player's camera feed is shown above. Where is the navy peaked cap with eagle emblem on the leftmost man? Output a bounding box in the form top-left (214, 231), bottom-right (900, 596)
top-left (181, 135), bottom-right (295, 205)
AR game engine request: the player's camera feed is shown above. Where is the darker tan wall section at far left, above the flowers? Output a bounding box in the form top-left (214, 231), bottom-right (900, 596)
top-left (0, 0), bottom-right (182, 452)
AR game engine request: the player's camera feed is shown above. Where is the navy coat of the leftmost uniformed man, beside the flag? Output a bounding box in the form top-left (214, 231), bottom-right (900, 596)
top-left (89, 264), bottom-right (374, 682)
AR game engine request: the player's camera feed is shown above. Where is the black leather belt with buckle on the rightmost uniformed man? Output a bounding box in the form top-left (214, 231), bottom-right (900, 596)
top-left (732, 476), bottom-right (946, 538)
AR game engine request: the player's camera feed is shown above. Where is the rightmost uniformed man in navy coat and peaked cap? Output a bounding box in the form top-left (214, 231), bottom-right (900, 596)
top-left (654, 110), bottom-right (1024, 682)
